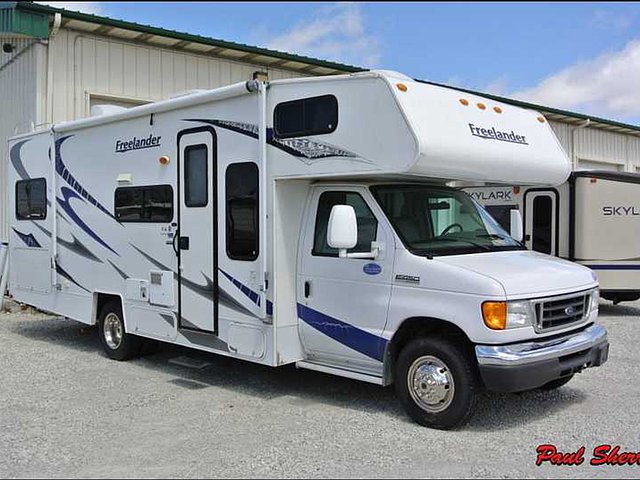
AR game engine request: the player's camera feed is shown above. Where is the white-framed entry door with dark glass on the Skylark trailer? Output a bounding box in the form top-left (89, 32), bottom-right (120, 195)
top-left (524, 190), bottom-right (558, 255)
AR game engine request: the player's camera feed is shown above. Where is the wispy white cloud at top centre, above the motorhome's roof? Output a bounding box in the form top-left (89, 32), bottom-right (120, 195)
top-left (266, 3), bottom-right (382, 67)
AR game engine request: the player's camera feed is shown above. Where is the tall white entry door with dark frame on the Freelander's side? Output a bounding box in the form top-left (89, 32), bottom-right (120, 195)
top-left (174, 127), bottom-right (218, 334)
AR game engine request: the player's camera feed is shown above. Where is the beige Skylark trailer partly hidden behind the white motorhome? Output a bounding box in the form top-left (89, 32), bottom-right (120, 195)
top-left (465, 170), bottom-right (640, 304)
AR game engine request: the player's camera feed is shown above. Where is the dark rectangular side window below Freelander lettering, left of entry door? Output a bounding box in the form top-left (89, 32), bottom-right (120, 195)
top-left (114, 185), bottom-right (173, 223)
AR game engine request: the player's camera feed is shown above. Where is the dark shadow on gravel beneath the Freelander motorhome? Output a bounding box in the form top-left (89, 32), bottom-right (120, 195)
top-left (11, 316), bottom-right (584, 431)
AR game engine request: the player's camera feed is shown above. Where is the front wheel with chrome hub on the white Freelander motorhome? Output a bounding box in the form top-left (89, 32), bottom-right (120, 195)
top-left (395, 337), bottom-right (481, 430)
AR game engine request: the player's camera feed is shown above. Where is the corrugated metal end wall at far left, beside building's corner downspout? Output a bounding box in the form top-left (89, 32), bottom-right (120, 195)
top-left (0, 37), bottom-right (45, 240)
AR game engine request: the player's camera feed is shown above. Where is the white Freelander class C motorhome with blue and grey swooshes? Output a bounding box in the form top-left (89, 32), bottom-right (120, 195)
top-left (9, 72), bottom-right (608, 428)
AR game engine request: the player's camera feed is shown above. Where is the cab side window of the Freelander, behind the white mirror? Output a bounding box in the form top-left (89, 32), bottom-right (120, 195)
top-left (312, 192), bottom-right (378, 257)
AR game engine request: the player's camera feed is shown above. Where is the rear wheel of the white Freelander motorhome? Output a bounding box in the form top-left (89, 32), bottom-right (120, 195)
top-left (98, 301), bottom-right (142, 361)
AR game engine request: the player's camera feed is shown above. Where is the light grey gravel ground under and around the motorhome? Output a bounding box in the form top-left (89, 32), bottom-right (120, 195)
top-left (0, 302), bottom-right (640, 478)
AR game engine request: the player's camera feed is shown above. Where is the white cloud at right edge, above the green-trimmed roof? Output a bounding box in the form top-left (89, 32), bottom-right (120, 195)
top-left (509, 39), bottom-right (640, 120)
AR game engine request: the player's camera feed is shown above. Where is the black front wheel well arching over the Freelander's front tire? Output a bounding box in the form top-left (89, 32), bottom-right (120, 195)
top-left (383, 317), bottom-right (473, 385)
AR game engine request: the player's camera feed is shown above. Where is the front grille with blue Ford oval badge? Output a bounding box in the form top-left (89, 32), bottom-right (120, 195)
top-left (535, 294), bottom-right (590, 331)
